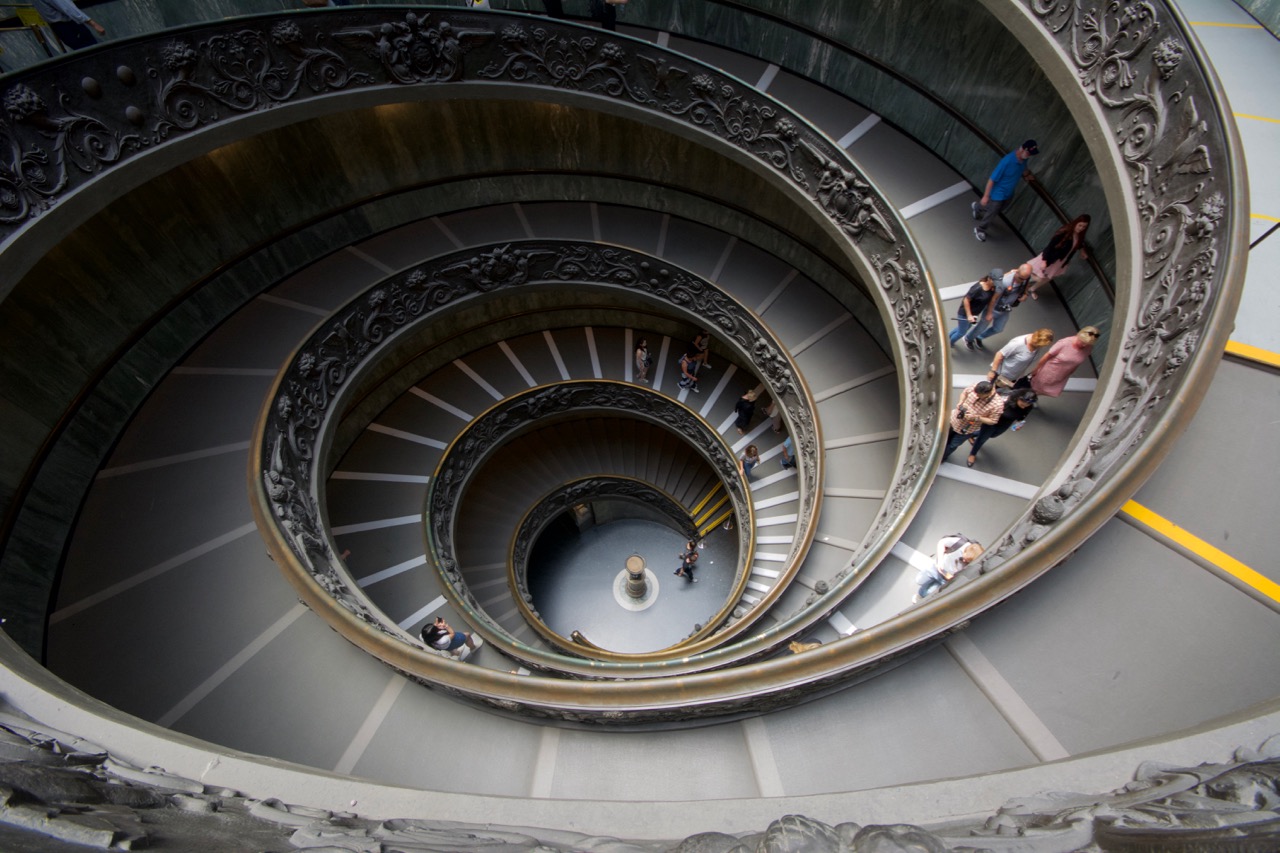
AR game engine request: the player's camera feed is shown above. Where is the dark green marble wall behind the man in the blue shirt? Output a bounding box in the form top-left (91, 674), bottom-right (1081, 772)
top-left (611, 0), bottom-right (1115, 343)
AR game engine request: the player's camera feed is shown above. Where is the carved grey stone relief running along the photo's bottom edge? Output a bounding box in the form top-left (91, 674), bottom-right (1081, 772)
top-left (0, 713), bottom-right (1280, 853)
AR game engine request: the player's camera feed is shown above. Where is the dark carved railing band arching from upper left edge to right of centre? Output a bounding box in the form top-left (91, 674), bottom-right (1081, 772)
top-left (0, 8), bottom-right (946, 676)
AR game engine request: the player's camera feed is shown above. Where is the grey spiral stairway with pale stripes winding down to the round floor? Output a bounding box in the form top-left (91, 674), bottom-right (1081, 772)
top-left (6, 4), bottom-right (1280, 838)
